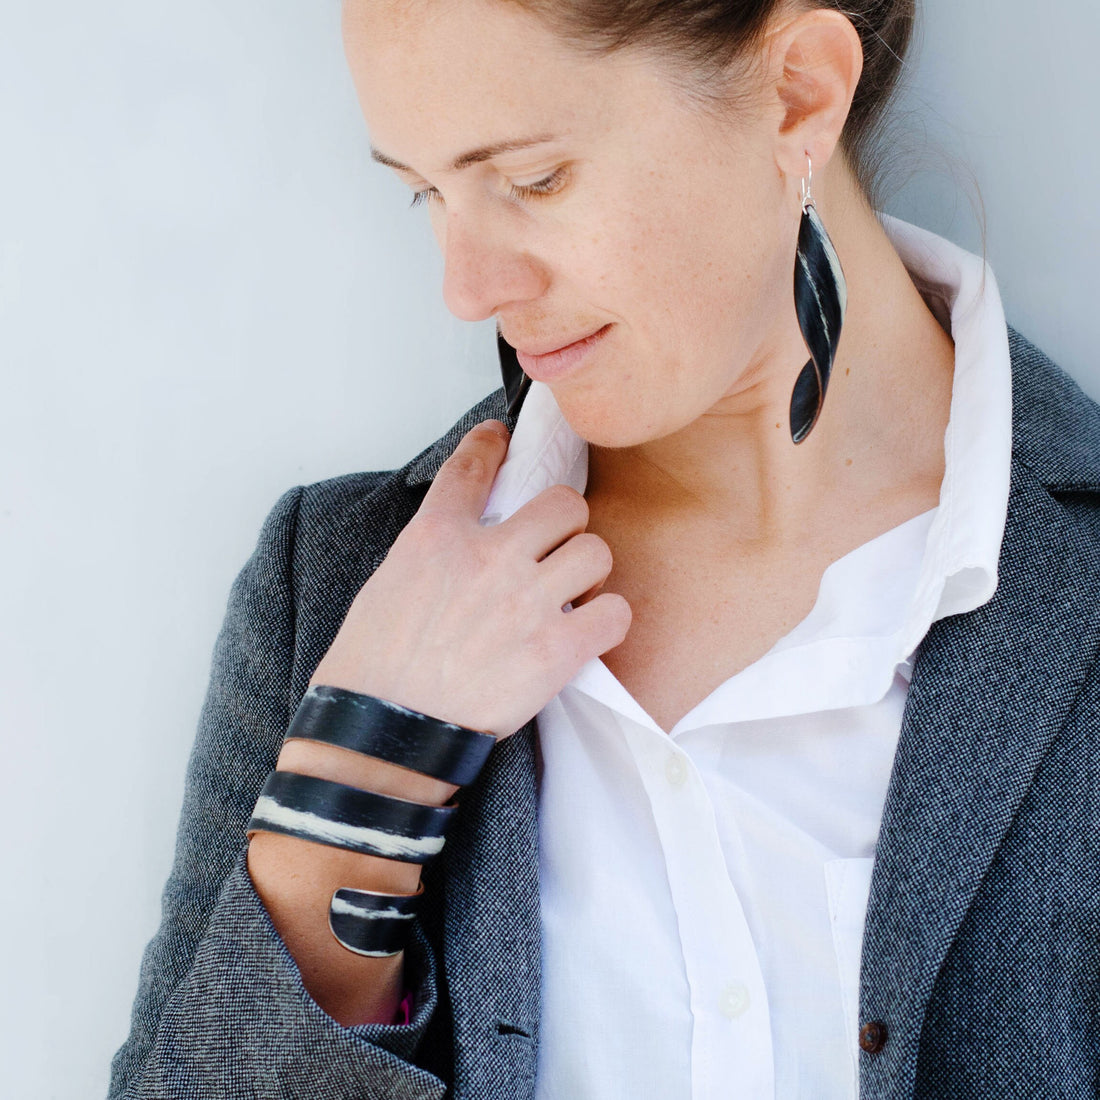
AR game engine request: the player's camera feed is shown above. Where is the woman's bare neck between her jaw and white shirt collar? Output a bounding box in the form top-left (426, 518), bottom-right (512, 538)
top-left (587, 179), bottom-right (954, 546)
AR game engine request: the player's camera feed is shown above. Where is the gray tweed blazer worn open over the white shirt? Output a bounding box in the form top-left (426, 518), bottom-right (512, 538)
top-left (110, 333), bottom-right (1100, 1100)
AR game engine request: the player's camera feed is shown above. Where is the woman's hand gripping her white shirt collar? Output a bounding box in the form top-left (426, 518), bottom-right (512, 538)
top-left (310, 420), bottom-right (630, 737)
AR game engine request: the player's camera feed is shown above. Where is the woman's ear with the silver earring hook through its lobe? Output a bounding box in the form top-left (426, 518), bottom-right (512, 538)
top-left (771, 8), bottom-right (864, 178)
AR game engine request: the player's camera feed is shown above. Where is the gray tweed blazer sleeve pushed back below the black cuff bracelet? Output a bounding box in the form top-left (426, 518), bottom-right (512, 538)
top-left (109, 488), bottom-right (446, 1100)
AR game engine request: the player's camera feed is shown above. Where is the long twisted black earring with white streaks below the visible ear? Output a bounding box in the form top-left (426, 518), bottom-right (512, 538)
top-left (791, 159), bottom-right (848, 443)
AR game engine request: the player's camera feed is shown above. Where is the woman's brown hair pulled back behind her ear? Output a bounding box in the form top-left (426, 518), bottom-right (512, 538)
top-left (503, 0), bottom-right (916, 198)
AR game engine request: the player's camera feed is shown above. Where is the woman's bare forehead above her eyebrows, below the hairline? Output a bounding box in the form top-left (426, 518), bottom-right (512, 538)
top-left (343, 0), bottom-right (686, 173)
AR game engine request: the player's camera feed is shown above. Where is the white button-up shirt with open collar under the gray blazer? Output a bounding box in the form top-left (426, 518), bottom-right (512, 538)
top-left (484, 218), bottom-right (1011, 1100)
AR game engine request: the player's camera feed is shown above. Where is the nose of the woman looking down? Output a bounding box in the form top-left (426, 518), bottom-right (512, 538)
top-left (437, 211), bottom-right (549, 321)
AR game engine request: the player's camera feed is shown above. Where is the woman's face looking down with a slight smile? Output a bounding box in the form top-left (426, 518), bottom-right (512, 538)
top-left (344, 0), bottom-right (804, 447)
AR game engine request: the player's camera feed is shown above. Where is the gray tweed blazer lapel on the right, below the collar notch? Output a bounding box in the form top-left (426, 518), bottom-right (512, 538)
top-left (860, 463), bottom-right (1100, 1097)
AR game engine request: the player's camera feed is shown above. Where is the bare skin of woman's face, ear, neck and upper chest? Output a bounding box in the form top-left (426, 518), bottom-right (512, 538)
top-left (344, 0), bottom-right (953, 727)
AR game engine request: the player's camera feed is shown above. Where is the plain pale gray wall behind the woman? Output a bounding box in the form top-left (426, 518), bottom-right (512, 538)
top-left (0, 0), bottom-right (1100, 1100)
